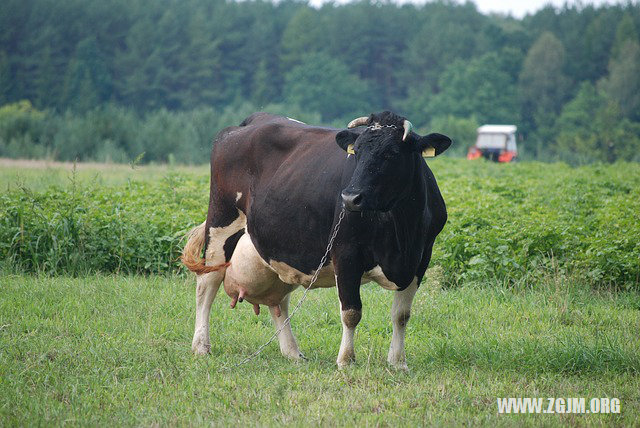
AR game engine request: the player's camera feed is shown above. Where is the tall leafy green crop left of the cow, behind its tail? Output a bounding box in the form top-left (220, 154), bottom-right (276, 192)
top-left (0, 171), bottom-right (207, 275)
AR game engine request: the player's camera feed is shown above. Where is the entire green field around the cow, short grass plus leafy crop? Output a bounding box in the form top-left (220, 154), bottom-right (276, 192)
top-left (0, 158), bottom-right (640, 426)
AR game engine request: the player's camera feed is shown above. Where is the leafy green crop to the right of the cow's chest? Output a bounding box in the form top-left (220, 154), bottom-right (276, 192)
top-left (434, 160), bottom-right (640, 287)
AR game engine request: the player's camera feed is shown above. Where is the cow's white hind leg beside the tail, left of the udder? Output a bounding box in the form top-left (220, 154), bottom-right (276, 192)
top-left (191, 210), bottom-right (247, 354)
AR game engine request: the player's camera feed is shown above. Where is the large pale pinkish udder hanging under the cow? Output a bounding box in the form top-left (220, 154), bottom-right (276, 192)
top-left (224, 233), bottom-right (297, 313)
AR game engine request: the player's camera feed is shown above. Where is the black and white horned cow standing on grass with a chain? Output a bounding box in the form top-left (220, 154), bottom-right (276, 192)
top-left (182, 111), bottom-right (452, 369)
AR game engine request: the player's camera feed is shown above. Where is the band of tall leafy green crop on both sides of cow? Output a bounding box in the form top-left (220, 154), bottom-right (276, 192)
top-left (0, 158), bottom-right (640, 288)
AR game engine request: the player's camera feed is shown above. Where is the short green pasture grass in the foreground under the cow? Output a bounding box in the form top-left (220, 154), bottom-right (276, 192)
top-left (0, 269), bottom-right (640, 426)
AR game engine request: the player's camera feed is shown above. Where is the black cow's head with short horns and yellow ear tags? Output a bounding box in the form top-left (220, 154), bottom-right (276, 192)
top-left (336, 111), bottom-right (451, 211)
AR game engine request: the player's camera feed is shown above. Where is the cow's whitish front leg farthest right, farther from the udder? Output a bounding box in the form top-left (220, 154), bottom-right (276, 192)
top-left (387, 279), bottom-right (418, 370)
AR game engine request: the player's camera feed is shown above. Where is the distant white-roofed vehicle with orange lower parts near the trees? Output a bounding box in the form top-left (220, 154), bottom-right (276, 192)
top-left (467, 125), bottom-right (518, 162)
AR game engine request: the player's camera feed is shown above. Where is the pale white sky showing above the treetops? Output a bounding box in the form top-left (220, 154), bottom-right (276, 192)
top-left (310, 0), bottom-right (626, 18)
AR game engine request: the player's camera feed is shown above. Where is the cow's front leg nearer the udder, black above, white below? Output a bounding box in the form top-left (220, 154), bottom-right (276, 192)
top-left (336, 272), bottom-right (362, 368)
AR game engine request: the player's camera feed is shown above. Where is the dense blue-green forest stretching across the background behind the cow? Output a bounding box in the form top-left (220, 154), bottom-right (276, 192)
top-left (0, 0), bottom-right (640, 164)
